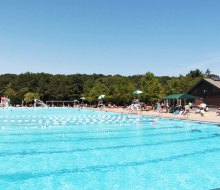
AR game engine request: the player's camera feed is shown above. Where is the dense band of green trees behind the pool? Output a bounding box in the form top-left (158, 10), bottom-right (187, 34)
top-left (0, 69), bottom-right (217, 105)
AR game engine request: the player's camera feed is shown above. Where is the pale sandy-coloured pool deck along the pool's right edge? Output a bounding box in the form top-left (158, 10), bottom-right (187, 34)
top-left (92, 108), bottom-right (220, 124)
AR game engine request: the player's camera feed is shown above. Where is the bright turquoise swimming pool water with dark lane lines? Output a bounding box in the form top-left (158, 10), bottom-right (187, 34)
top-left (0, 108), bottom-right (220, 190)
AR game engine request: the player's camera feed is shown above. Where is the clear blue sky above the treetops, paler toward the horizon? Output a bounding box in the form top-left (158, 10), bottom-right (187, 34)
top-left (0, 0), bottom-right (220, 76)
